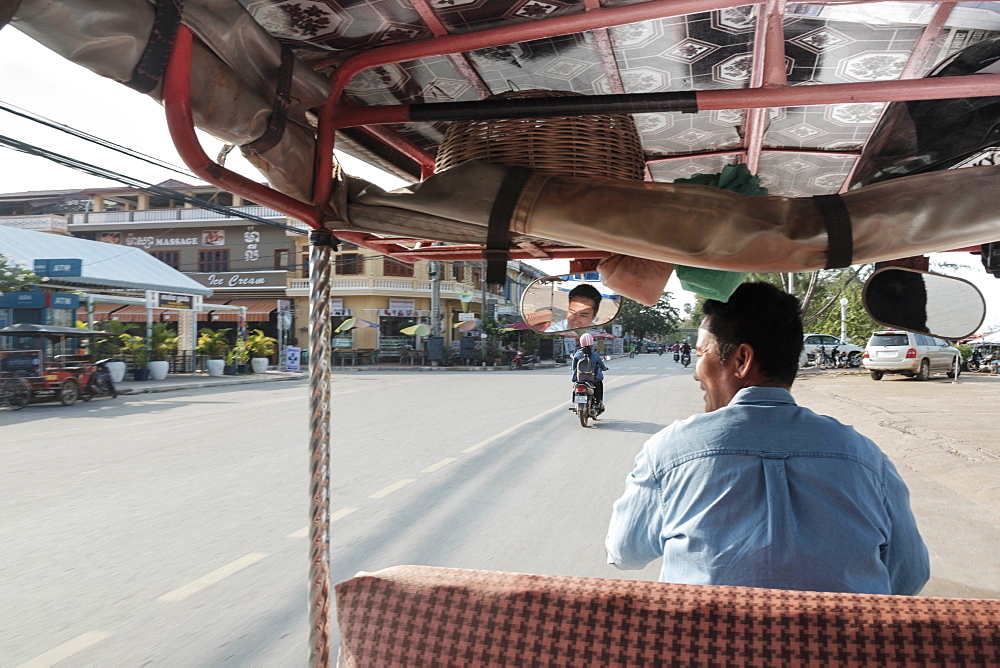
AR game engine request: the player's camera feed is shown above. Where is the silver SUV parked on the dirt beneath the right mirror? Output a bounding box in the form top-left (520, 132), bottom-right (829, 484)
top-left (863, 329), bottom-right (961, 380)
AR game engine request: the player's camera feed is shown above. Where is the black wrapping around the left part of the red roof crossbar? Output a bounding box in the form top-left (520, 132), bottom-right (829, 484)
top-left (409, 91), bottom-right (698, 121)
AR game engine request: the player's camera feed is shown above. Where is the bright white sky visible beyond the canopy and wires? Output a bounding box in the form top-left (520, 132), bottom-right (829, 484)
top-left (0, 26), bottom-right (1000, 331)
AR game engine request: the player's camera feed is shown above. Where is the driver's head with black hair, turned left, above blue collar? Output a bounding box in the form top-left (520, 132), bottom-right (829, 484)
top-left (694, 283), bottom-right (802, 412)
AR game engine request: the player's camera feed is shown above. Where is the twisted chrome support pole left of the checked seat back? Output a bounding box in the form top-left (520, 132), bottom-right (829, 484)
top-left (309, 229), bottom-right (335, 668)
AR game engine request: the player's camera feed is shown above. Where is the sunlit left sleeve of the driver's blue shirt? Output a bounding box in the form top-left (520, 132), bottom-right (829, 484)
top-left (604, 439), bottom-right (663, 570)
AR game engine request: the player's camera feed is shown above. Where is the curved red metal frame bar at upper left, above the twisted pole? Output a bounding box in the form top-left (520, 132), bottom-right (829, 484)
top-left (163, 24), bottom-right (320, 228)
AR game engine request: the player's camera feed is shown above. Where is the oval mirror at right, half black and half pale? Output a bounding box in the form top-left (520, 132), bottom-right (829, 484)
top-left (861, 267), bottom-right (986, 340)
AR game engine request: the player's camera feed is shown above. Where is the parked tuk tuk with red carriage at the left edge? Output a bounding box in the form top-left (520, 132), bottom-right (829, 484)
top-left (0, 324), bottom-right (118, 410)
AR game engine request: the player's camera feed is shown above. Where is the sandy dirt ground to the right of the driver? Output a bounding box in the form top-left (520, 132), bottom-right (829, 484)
top-left (792, 370), bottom-right (1000, 598)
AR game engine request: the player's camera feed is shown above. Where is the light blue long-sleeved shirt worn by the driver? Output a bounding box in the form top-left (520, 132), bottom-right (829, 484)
top-left (606, 387), bottom-right (930, 594)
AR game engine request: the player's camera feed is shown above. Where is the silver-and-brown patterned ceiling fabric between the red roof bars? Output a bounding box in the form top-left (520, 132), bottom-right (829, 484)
top-left (230, 0), bottom-right (1000, 196)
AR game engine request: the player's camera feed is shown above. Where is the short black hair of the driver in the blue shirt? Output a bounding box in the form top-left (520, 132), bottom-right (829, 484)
top-left (701, 283), bottom-right (802, 387)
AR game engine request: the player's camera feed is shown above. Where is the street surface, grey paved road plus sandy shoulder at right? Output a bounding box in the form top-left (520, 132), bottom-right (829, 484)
top-left (0, 362), bottom-right (1000, 666)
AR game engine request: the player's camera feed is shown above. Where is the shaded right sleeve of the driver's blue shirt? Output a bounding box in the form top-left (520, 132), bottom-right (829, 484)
top-left (881, 458), bottom-right (931, 596)
